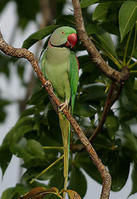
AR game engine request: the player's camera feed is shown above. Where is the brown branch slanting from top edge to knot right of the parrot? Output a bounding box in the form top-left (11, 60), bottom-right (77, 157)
top-left (72, 0), bottom-right (129, 82)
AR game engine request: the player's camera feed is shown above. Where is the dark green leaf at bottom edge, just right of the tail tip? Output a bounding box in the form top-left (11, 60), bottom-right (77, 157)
top-left (69, 165), bottom-right (87, 198)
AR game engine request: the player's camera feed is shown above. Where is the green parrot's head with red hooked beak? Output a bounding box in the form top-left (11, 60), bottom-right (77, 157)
top-left (49, 26), bottom-right (77, 48)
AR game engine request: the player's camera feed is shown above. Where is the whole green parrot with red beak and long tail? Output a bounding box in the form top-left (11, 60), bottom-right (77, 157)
top-left (41, 26), bottom-right (79, 190)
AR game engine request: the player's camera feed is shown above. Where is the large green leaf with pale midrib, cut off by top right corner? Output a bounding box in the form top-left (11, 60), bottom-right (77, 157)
top-left (119, 1), bottom-right (137, 41)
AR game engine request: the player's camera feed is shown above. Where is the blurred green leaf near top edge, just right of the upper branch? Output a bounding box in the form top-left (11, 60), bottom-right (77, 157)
top-left (92, 2), bottom-right (111, 21)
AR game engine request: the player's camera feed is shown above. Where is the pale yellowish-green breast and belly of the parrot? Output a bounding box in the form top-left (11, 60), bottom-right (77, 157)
top-left (45, 47), bottom-right (70, 102)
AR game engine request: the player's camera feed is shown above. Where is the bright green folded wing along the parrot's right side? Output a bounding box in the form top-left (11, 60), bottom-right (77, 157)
top-left (69, 51), bottom-right (79, 114)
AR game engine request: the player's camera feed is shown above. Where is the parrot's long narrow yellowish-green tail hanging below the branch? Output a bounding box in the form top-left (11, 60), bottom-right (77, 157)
top-left (59, 113), bottom-right (70, 190)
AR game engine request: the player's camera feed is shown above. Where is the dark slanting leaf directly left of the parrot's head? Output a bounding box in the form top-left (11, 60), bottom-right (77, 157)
top-left (22, 25), bottom-right (59, 49)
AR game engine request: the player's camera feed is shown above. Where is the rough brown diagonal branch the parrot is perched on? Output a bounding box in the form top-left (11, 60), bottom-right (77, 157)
top-left (0, 30), bottom-right (111, 199)
